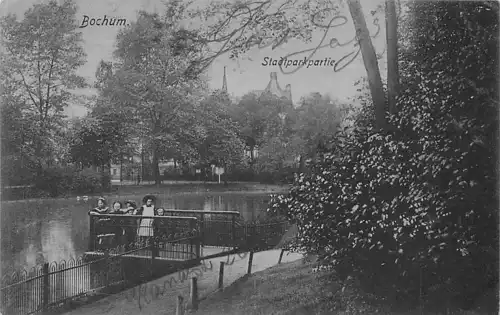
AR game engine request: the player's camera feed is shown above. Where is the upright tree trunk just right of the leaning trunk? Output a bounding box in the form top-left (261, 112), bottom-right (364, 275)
top-left (385, 0), bottom-right (399, 114)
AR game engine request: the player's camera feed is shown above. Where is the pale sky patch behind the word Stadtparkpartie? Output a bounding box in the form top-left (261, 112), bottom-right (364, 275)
top-left (203, 0), bottom-right (387, 102)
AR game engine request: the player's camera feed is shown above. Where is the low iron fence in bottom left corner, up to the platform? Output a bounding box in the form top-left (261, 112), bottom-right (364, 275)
top-left (0, 241), bottom-right (147, 315)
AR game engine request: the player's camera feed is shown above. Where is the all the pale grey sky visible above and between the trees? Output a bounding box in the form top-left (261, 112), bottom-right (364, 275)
top-left (0, 0), bottom-right (386, 116)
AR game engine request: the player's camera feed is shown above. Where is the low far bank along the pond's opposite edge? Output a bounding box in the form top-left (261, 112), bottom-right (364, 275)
top-left (1, 181), bottom-right (289, 202)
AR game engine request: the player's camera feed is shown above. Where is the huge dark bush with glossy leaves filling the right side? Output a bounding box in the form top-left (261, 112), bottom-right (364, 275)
top-left (270, 2), bottom-right (498, 312)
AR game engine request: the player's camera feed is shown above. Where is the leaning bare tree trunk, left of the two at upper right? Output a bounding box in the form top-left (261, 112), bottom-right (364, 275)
top-left (348, 0), bottom-right (385, 130)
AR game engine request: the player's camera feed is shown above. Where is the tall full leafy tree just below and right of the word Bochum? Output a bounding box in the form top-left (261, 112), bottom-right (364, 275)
top-left (101, 1), bottom-right (203, 184)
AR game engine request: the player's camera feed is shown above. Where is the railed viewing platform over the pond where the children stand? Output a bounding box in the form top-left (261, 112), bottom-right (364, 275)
top-left (86, 209), bottom-right (241, 262)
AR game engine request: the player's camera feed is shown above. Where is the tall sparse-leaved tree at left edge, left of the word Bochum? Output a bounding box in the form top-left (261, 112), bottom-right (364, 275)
top-left (0, 0), bottom-right (85, 171)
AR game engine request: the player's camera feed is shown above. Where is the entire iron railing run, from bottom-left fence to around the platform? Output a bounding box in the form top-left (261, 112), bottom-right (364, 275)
top-left (0, 215), bottom-right (290, 315)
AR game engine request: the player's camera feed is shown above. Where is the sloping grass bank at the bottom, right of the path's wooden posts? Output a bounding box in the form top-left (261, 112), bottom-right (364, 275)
top-left (196, 260), bottom-right (496, 315)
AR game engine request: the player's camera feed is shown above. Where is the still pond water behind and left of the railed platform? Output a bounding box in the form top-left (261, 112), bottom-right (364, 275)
top-left (0, 192), bottom-right (270, 274)
